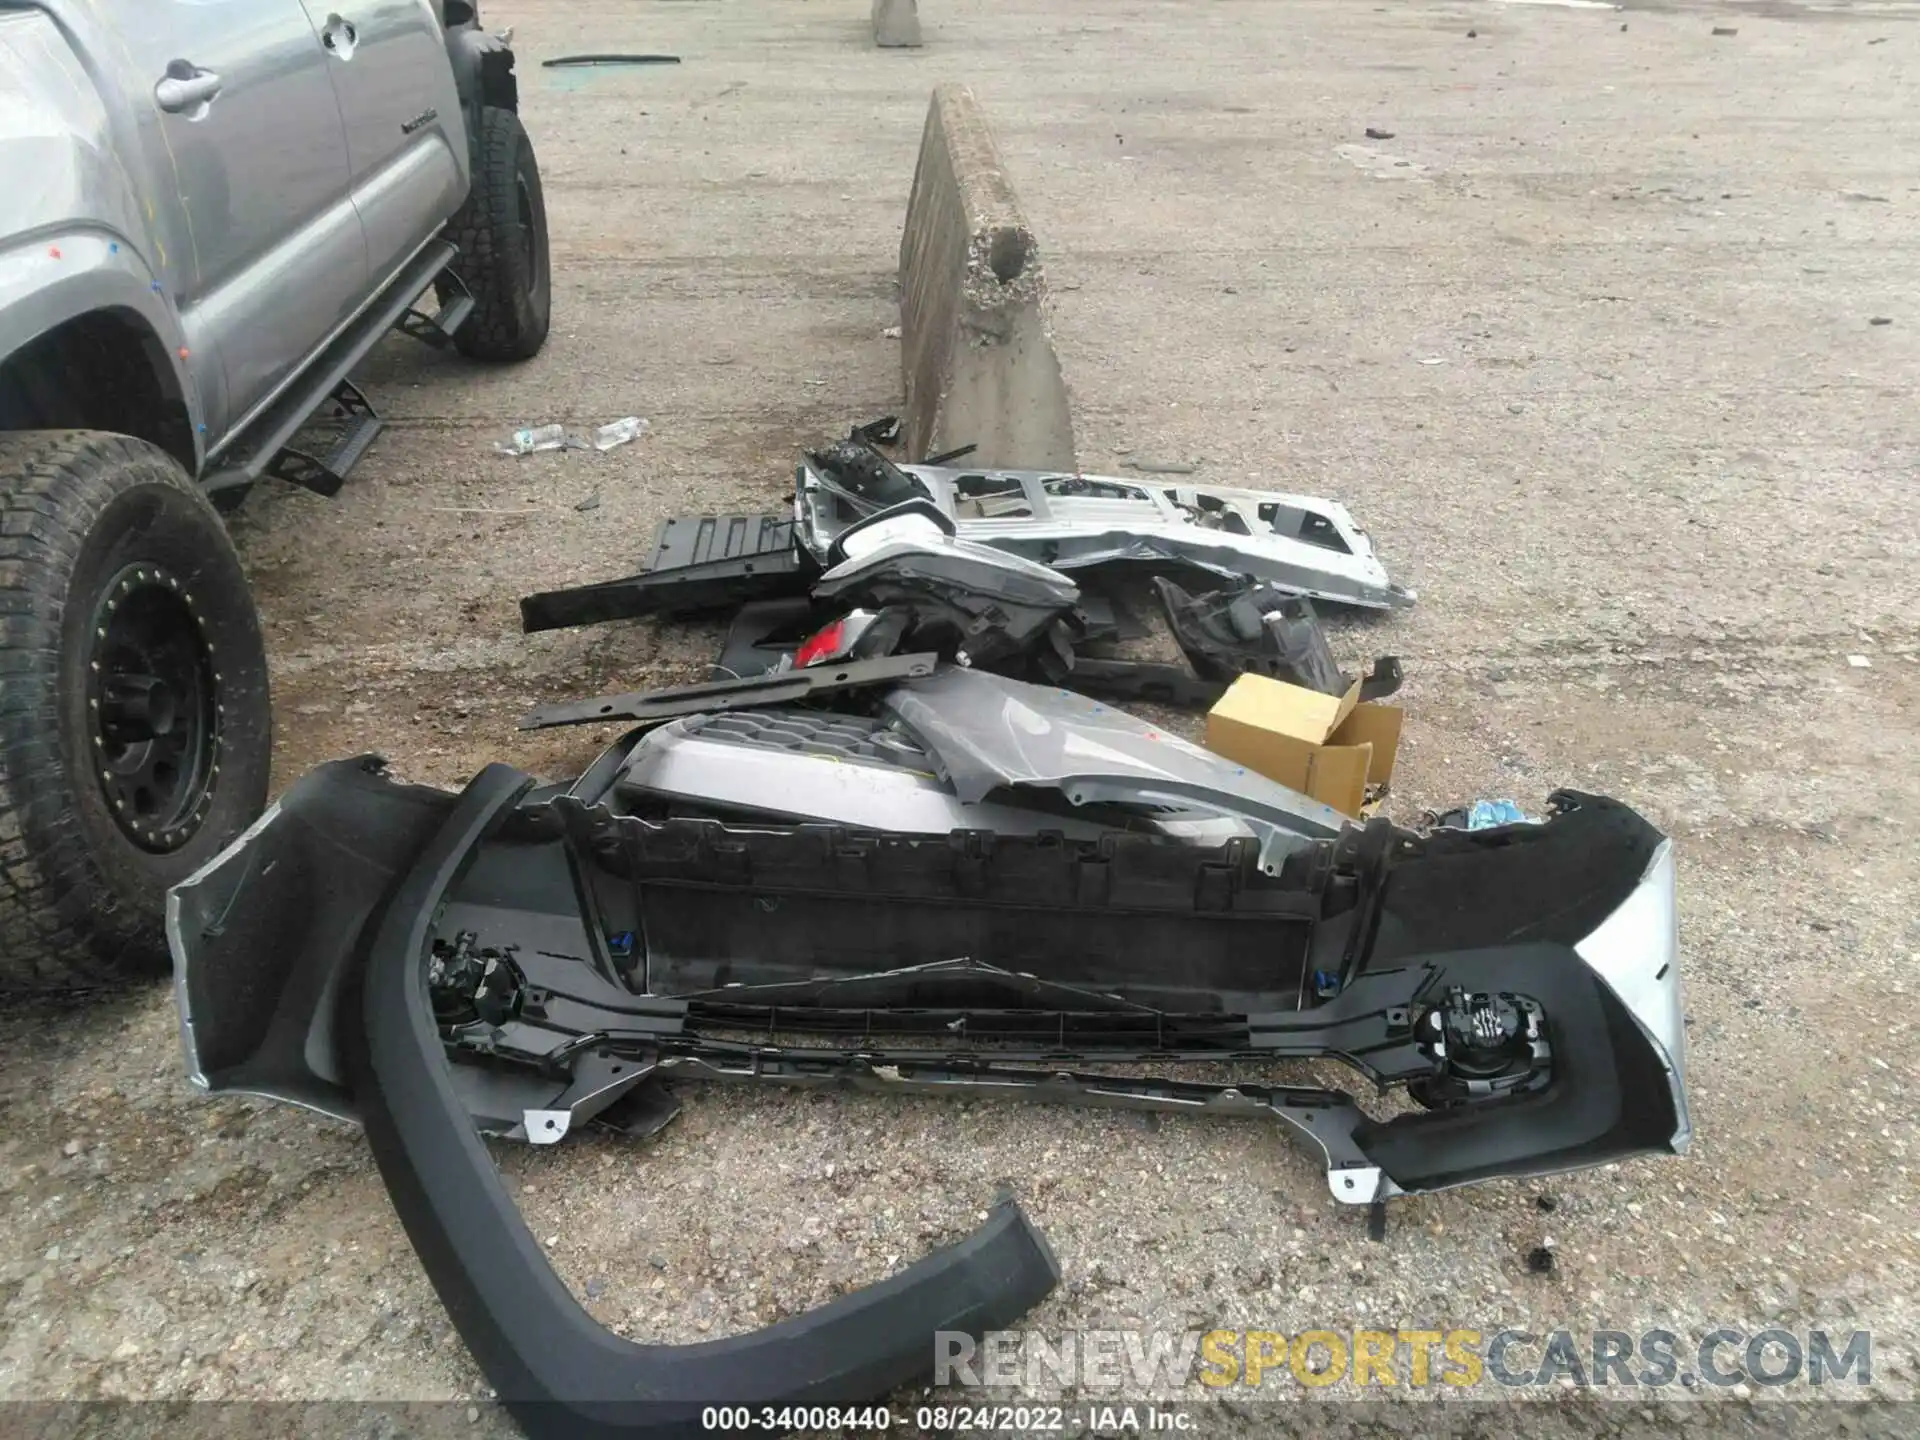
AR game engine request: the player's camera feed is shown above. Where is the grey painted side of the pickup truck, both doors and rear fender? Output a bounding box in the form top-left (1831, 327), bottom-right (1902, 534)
top-left (0, 0), bottom-right (468, 457)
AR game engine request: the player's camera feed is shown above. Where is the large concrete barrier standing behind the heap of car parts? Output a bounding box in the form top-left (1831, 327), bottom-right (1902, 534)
top-left (900, 84), bottom-right (1077, 470)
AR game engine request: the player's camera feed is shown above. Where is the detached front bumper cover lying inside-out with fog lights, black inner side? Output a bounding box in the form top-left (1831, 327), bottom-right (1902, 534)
top-left (169, 744), bottom-right (1688, 1205)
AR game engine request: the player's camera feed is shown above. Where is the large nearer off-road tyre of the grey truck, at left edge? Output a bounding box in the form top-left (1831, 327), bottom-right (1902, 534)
top-left (0, 430), bottom-right (273, 991)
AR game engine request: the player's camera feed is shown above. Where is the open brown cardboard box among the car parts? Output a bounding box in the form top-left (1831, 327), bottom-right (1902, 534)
top-left (1206, 676), bottom-right (1404, 818)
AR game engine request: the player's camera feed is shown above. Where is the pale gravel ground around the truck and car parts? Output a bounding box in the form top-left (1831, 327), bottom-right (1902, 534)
top-left (0, 0), bottom-right (1920, 1432)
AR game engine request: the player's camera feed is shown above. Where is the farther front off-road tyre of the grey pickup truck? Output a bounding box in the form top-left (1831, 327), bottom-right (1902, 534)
top-left (438, 106), bottom-right (553, 361)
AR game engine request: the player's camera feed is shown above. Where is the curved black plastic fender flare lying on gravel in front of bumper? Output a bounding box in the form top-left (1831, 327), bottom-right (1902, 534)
top-left (342, 764), bottom-right (1060, 1440)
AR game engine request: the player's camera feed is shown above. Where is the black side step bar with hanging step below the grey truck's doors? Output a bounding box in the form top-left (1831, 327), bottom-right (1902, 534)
top-left (202, 240), bottom-right (459, 505)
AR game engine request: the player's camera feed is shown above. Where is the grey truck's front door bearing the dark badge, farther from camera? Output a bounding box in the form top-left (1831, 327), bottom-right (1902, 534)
top-left (305, 0), bottom-right (467, 280)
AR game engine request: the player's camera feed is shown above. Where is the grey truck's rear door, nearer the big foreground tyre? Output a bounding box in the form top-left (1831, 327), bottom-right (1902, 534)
top-left (139, 0), bottom-right (367, 440)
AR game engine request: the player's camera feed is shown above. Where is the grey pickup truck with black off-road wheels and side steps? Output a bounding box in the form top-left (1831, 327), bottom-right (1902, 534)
top-left (0, 0), bottom-right (551, 989)
